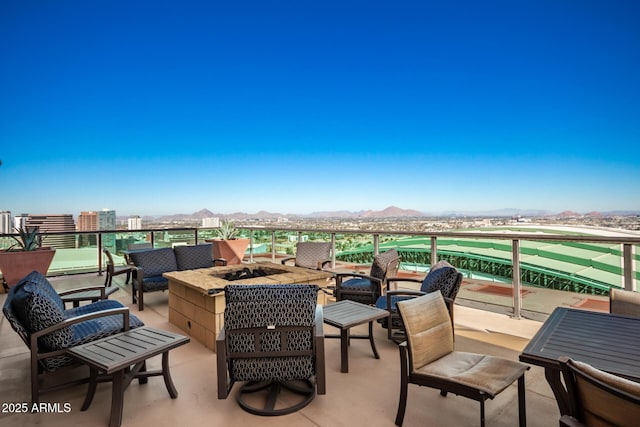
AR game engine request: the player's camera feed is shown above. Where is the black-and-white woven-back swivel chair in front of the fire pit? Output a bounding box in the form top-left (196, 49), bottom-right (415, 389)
top-left (216, 285), bottom-right (326, 415)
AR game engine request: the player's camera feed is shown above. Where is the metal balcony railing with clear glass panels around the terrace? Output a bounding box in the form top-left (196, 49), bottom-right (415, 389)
top-left (0, 227), bottom-right (640, 318)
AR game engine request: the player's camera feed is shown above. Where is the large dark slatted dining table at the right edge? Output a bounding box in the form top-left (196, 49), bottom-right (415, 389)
top-left (520, 307), bottom-right (640, 415)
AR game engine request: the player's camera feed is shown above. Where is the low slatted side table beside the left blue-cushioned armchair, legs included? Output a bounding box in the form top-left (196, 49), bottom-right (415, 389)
top-left (68, 326), bottom-right (189, 427)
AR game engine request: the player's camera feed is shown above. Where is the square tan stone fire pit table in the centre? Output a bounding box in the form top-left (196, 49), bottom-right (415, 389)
top-left (163, 262), bottom-right (333, 351)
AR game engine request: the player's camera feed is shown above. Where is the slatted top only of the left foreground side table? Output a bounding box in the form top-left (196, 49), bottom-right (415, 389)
top-left (68, 326), bottom-right (189, 374)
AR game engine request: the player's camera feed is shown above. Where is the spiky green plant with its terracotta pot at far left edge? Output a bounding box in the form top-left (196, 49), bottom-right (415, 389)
top-left (0, 227), bottom-right (56, 287)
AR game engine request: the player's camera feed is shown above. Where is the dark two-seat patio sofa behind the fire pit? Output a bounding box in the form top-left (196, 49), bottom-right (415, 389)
top-left (129, 243), bottom-right (227, 311)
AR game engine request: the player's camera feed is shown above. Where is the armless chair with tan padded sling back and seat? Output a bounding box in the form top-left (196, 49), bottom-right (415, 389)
top-left (396, 292), bottom-right (529, 426)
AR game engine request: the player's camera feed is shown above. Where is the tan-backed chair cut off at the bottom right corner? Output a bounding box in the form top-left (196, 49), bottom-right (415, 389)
top-left (560, 358), bottom-right (640, 427)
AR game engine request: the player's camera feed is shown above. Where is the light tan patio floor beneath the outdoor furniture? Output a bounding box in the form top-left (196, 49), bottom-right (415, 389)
top-left (0, 273), bottom-right (559, 427)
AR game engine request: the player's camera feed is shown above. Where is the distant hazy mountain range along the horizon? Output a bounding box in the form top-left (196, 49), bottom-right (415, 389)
top-left (125, 206), bottom-right (640, 222)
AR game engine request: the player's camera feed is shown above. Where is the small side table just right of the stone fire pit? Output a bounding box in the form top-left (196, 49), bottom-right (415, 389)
top-left (323, 300), bottom-right (389, 372)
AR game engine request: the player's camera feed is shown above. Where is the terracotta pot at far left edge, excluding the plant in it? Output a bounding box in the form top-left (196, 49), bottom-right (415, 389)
top-left (0, 248), bottom-right (56, 287)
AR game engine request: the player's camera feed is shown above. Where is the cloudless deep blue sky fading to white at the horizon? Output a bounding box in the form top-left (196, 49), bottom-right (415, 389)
top-left (0, 0), bottom-right (640, 215)
